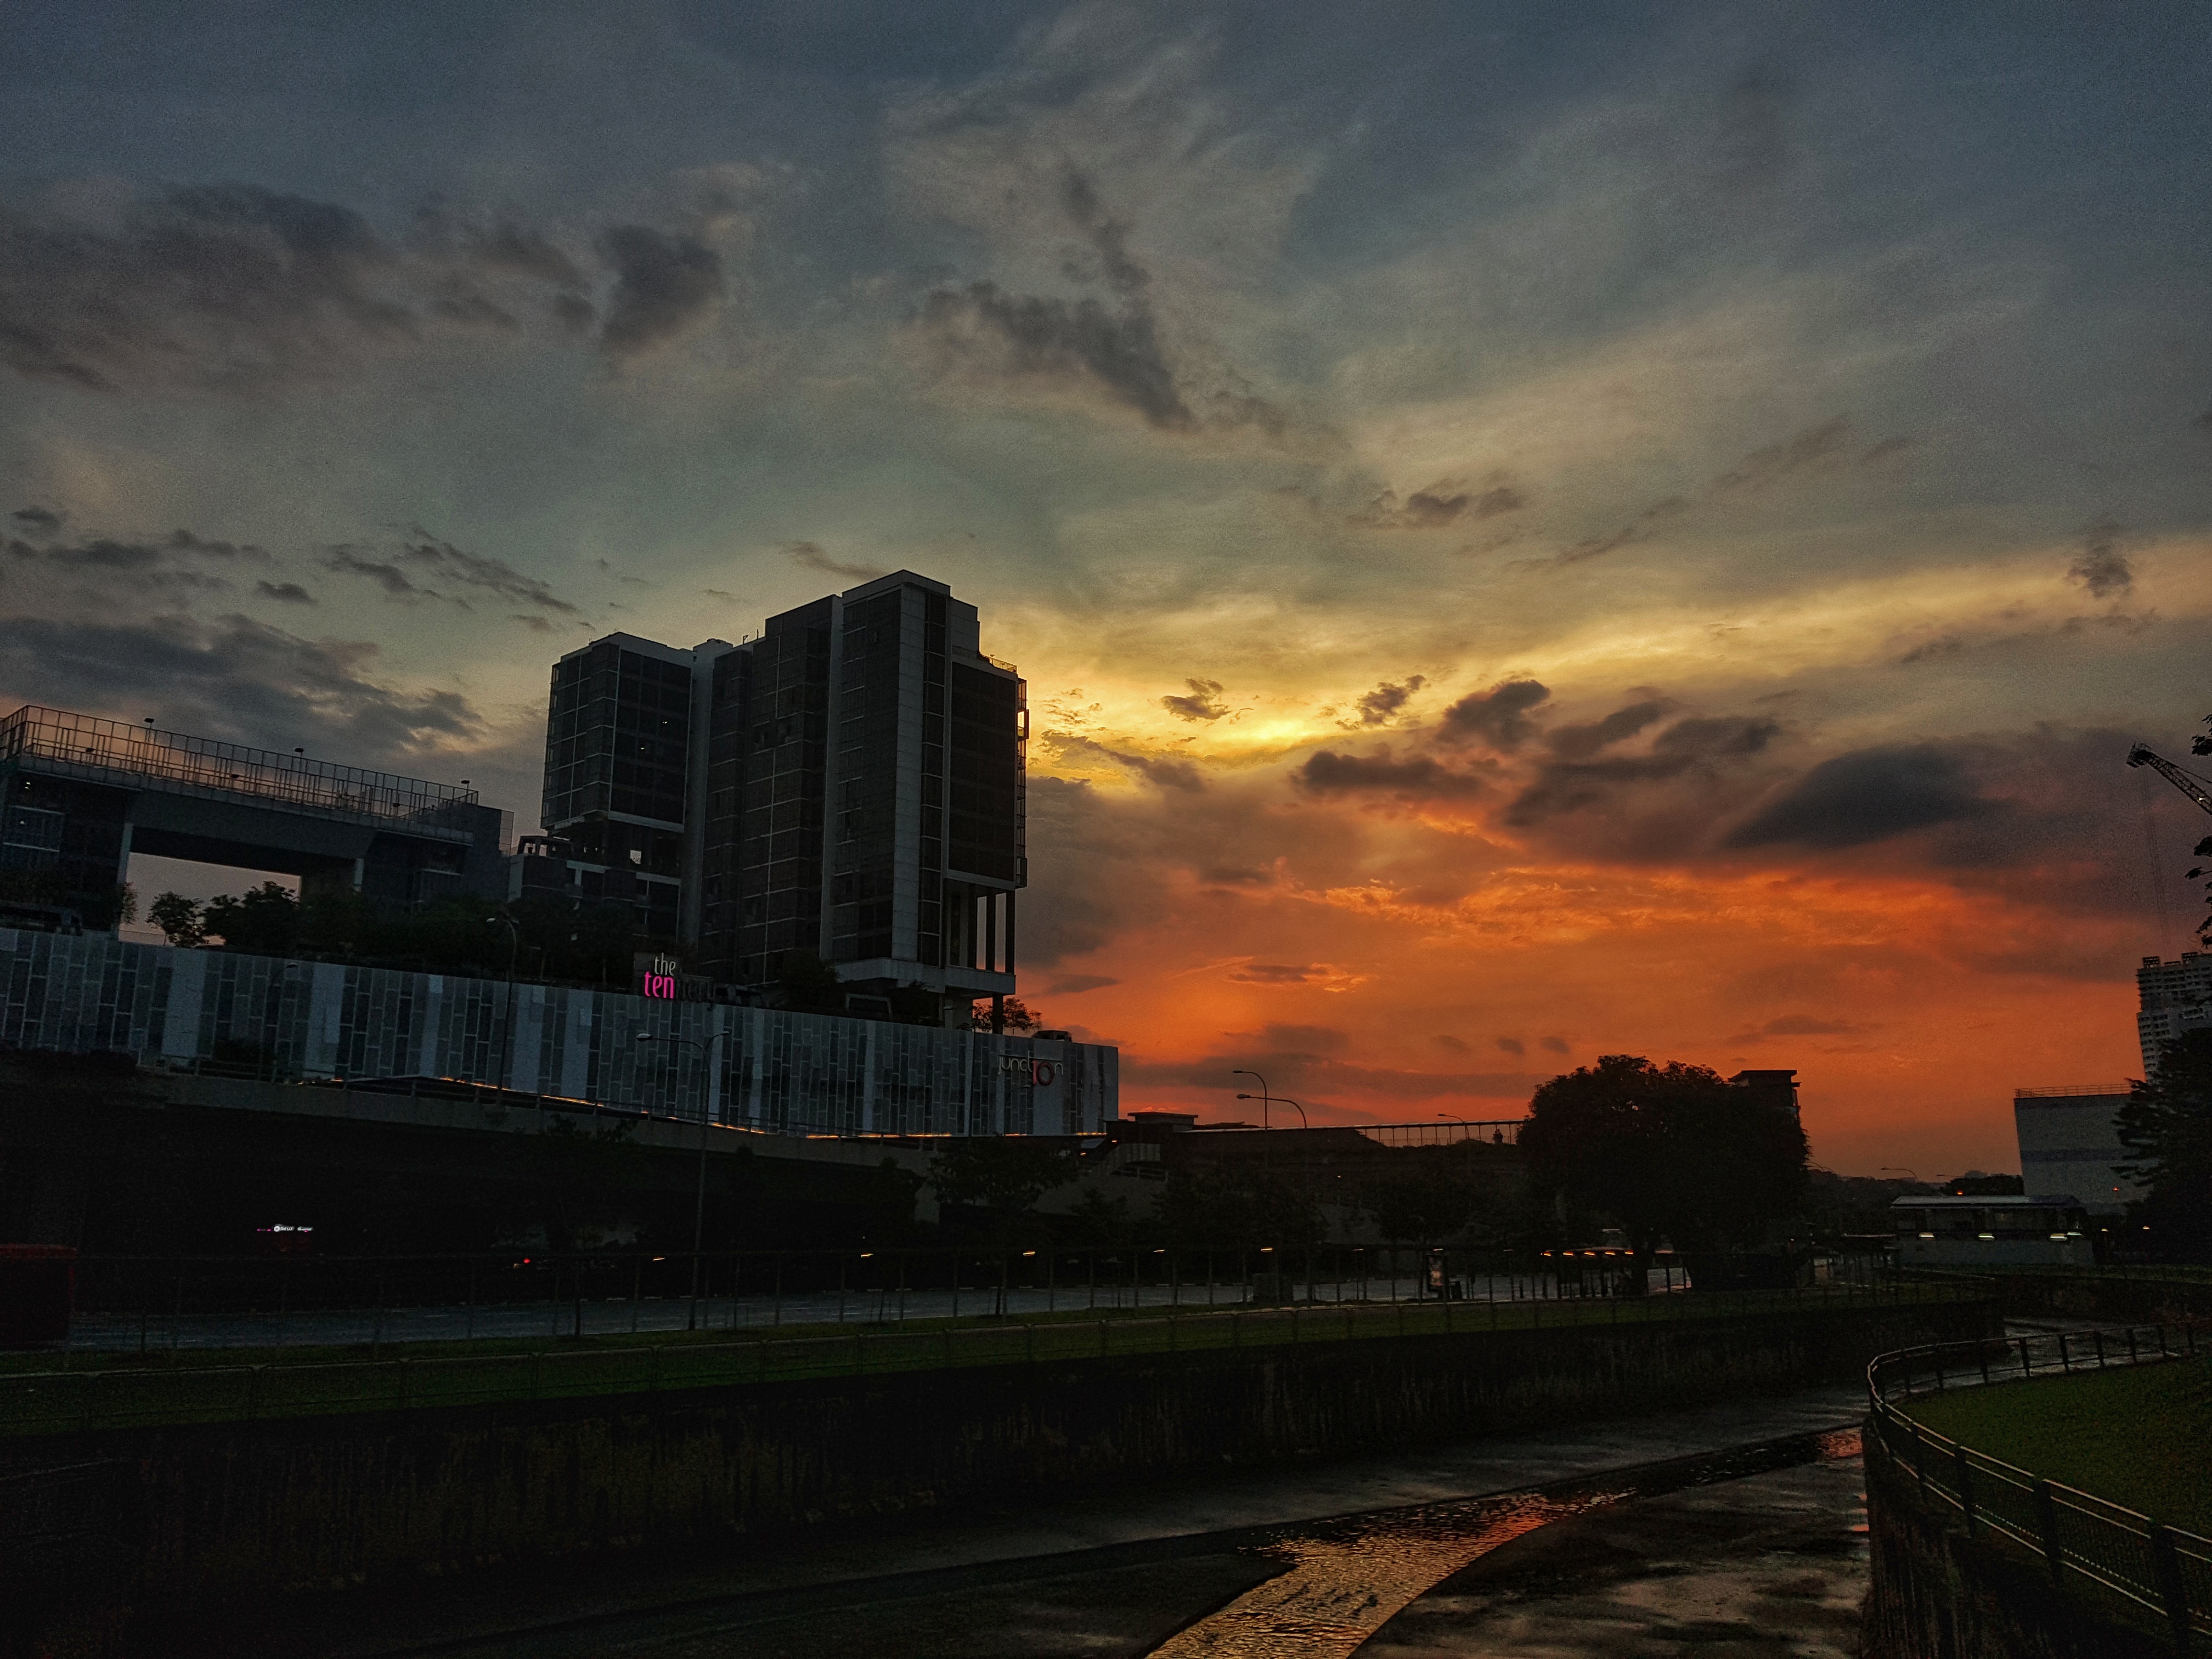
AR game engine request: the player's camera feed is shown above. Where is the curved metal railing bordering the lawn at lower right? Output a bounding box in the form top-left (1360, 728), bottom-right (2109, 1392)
top-left (1867, 1325), bottom-right (2212, 1652)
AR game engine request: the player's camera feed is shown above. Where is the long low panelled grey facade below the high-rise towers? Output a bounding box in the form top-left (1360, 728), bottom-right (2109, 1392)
top-left (0, 927), bottom-right (1119, 1135)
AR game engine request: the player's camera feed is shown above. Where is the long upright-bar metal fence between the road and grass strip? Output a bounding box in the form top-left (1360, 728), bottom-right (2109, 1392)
top-left (43, 1230), bottom-right (1874, 1352)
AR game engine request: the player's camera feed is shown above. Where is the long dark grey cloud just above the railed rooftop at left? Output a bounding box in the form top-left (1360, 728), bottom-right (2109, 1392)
top-left (0, 615), bottom-right (484, 765)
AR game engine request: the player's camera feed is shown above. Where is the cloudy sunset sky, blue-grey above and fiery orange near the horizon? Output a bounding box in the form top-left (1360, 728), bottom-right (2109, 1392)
top-left (0, 0), bottom-right (2212, 1177)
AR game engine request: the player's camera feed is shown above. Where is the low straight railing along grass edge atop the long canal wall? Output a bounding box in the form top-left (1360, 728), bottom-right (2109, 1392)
top-left (0, 1285), bottom-right (1982, 1436)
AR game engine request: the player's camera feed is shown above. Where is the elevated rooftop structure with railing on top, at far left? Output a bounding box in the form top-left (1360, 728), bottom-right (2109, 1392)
top-left (0, 706), bottom-right (504, 927)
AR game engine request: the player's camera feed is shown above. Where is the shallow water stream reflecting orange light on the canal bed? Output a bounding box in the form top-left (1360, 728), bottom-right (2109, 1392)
top-left (1153, 1429), bottom-right (1860, 1659)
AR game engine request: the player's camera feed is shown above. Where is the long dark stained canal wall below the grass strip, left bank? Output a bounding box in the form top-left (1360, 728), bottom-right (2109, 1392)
top-left (0, 1303), bottom-right (1997, 1645)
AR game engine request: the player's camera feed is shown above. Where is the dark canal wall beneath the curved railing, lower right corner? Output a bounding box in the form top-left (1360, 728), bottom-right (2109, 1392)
top-left (1860, 1423), bottom-right (2172, 1659)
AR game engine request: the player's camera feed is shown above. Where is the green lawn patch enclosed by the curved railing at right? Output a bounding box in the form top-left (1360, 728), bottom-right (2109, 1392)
top-left (1905, 1356), bottom-right (2212, 1537)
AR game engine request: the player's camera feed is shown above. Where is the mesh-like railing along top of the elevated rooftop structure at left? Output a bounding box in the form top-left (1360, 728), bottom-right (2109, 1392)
top-left (0, 703), bottom-right (476, 840)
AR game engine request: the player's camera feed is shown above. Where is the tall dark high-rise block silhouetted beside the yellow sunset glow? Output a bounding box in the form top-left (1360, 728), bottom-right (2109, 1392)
top-left (520, 571), bottom-right (1029, 1013)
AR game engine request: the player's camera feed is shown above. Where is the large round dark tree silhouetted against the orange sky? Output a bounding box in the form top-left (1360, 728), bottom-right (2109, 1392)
top-left (1520, 1055), bottom-right (1809, 1283)
